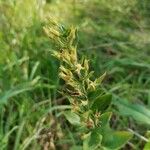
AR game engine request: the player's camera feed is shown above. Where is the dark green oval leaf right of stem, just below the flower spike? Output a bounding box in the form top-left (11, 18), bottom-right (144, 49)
top-left (91, 94), bottom-right (112, 112)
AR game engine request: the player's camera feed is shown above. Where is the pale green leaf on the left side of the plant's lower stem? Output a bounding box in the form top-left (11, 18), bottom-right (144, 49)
top-left (63, 111), bottom-right (80, 125)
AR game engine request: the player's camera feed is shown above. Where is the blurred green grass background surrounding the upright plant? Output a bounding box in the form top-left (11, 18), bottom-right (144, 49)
top-left (0, 0), bottom-right (150, 150)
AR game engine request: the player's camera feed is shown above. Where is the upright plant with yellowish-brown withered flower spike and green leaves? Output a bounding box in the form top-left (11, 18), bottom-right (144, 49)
top-left (44, 21), bottom-right (132, 150)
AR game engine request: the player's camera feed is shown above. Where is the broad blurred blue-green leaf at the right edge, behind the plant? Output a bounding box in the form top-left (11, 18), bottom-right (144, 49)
top-left (114, 100), bottom-right (150, 125)
